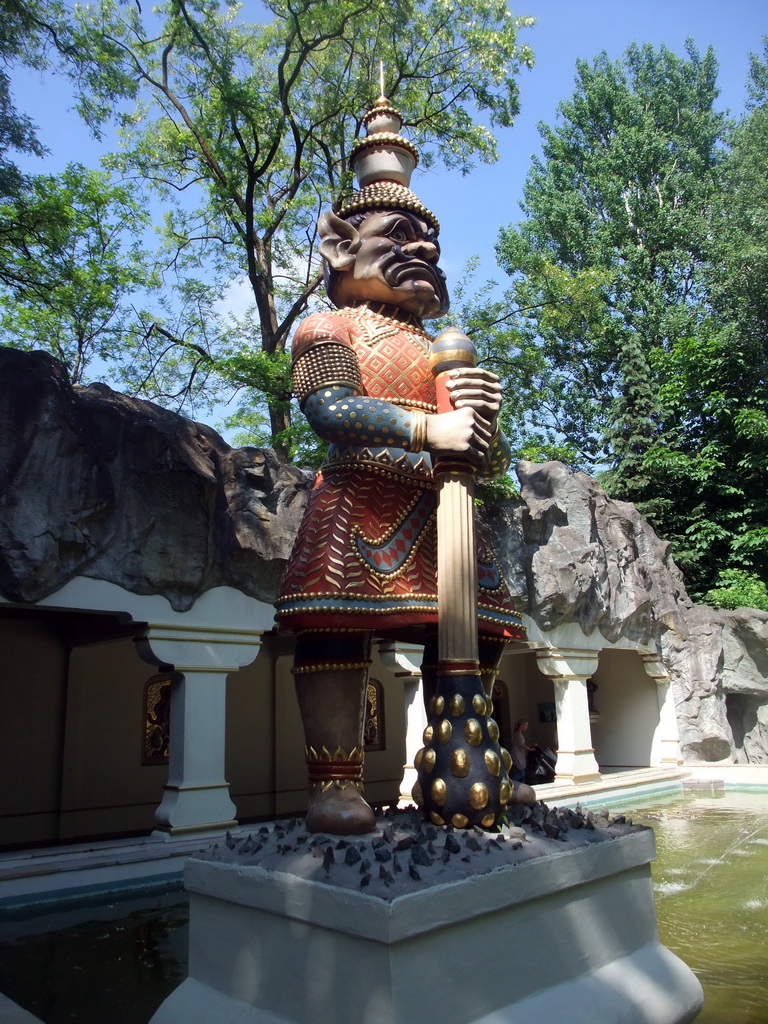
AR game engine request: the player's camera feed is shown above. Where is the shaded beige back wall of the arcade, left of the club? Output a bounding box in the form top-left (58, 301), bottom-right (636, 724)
top-left (0, 614), bottom-right (406, 847)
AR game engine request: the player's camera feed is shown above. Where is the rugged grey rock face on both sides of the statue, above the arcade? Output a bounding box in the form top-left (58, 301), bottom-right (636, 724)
top-left (0, 348), bottom-right (768, 762)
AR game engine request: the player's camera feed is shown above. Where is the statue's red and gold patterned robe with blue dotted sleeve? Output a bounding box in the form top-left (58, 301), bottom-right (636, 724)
top-left (278, 307), bottom-right (524, 640)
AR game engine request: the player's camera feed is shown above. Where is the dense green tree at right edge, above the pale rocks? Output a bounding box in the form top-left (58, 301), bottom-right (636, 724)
top-left (646, 39), bottom-right (768, 599)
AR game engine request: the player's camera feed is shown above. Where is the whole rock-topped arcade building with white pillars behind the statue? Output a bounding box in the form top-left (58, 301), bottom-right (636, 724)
top-left (7, 349), bottom-right (757, 850)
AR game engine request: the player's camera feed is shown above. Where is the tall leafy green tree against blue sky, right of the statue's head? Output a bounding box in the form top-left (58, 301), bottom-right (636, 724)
top-left (497, 42), bottom-right (726, 471)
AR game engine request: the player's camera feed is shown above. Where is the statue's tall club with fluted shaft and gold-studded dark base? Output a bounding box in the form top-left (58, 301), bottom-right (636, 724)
top-left (413, 328), bottom-right (513, 828)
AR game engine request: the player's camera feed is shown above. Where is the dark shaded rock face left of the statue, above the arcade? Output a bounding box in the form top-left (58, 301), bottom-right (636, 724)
top-left (0, 349), bottom-right (313, 611)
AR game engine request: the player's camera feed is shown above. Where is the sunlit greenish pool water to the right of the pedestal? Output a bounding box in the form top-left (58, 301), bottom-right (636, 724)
top-left (628, 790), bottom-right (768, 1024)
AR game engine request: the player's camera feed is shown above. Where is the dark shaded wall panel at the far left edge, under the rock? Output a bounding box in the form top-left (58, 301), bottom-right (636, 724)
top-left (0, 617), bottom-right (67, 846)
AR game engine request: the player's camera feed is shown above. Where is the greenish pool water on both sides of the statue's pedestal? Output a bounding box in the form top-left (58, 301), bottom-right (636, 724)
top-left (0, 791), bottom-right (768, 1024)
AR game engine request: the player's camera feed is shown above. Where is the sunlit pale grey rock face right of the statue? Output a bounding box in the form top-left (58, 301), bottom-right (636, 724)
top-left (487, 462), bottom-right (768, 763)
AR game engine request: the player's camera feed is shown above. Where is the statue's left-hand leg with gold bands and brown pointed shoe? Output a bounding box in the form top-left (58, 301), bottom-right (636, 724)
top-left (293, 633), bottom-right (376, 836)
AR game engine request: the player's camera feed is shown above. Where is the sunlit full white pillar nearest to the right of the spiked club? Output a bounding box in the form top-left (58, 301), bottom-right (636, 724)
top-left (537, 647), bottom-right (601, 785)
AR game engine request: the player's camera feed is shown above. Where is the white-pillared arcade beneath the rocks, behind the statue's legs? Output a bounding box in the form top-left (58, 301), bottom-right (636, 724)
top-left (0, 577), bottom-right (680, 849)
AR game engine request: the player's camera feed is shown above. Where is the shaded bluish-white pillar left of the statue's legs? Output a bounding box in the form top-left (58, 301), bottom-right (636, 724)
top-left (136, 625), bottom-right (261, 837)
